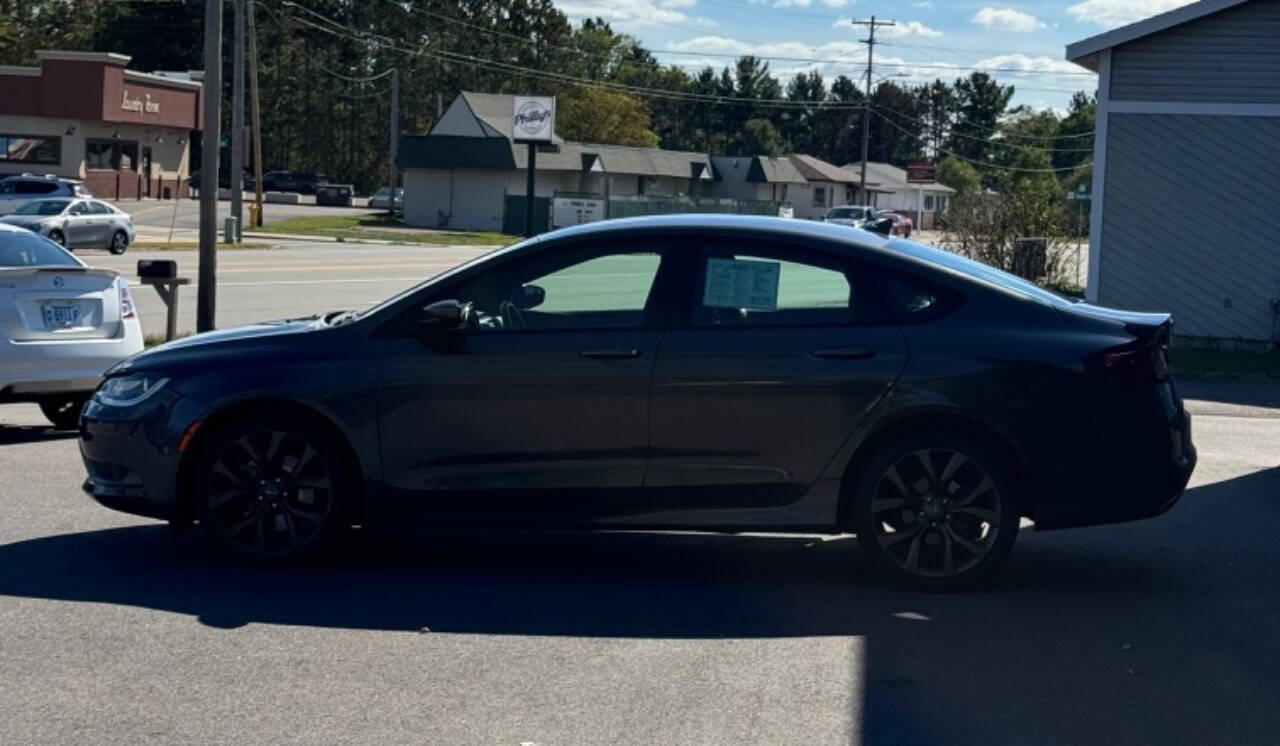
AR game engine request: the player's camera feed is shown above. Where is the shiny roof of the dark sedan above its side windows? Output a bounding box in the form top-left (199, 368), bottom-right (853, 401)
top-left (534, 214), bottom-right (890, 251)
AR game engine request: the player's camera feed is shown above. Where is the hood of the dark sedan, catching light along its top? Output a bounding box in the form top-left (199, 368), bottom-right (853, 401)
top-left (108, 316), bottom-right (330, 375)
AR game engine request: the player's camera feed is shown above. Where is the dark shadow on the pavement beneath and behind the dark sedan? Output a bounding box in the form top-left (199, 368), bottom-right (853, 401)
top-left (0, 468), bottom-right (1280, 745)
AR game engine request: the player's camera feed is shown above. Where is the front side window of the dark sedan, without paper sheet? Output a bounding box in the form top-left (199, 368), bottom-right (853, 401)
top-left (451, 250), bottom-right (662, 330)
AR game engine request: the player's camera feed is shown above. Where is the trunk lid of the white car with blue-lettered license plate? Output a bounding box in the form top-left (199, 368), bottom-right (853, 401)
top-left (0, 266), bottom-right (122, 343)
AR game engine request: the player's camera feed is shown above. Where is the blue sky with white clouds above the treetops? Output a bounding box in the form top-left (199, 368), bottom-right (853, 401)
top-left (557, 0), bottom-right (1188, 109)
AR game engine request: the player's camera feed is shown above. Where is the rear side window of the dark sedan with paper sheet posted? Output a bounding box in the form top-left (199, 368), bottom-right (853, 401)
top-left (694, 247), bottom-right (855, 326)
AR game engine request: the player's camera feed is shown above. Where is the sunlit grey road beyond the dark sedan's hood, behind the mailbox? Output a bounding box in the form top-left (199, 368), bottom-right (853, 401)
top-left (77, 242), bottom-right (490, 334)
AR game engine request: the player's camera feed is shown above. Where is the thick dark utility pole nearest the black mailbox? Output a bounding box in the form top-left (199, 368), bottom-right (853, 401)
top-left (196, 0), bottom-right (223, 331)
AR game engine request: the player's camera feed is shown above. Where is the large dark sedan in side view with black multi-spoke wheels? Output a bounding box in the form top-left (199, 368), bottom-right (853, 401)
top-left (81, 215), bottom-right (1196, 590)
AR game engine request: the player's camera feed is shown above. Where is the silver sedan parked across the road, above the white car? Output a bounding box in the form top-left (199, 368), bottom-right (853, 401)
top-left (0, 198), bottom-right (134, 253)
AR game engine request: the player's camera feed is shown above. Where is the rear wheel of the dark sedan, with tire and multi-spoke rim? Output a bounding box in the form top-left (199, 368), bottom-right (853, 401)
top-left (851, 429), bottom-right (1021, 591)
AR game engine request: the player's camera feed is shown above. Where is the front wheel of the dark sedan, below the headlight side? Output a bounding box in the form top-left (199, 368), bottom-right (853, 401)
top-left (195, 413), bottom-right (357, 566)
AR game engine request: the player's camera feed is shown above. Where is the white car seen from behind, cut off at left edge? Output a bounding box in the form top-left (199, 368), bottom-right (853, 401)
top-left (0, 224), bottom-right (142, 430)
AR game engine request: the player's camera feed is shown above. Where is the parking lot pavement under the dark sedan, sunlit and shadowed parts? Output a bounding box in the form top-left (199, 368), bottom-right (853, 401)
top-left (0, 386), bottom-right (1280, 745)
